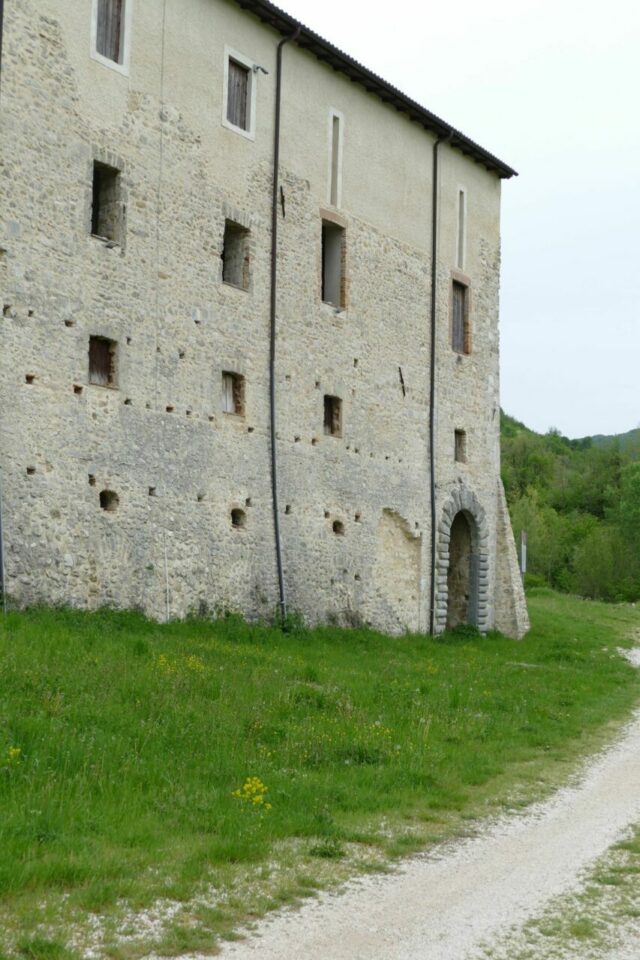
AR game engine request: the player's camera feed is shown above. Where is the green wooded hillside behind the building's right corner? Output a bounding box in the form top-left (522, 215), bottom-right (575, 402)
top-left (501, 413), bottom-right (640, 600)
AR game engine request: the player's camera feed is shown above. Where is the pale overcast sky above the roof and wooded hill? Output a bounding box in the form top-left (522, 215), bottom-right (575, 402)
top-left (279, 0), bottom-right (640, 437)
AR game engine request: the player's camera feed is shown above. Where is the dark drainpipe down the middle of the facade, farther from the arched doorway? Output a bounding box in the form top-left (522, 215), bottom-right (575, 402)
top-left (270, 26), bottom-right (301, 626)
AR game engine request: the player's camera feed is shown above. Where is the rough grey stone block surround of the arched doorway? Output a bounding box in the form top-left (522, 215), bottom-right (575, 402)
top-left (434, 484), bottom-right (490, 634)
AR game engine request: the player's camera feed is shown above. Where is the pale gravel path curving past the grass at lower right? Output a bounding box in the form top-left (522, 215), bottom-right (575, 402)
top-left (222, 711), bottom-right (640, 960)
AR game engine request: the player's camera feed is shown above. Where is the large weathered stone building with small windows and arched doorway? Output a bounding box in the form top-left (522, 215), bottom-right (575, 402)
top-left (0, 0), bottom-right (527, 637)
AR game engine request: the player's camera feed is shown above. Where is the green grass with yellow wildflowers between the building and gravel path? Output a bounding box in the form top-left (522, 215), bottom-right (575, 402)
top-left (0, 590), bottom-right (640, 960)
